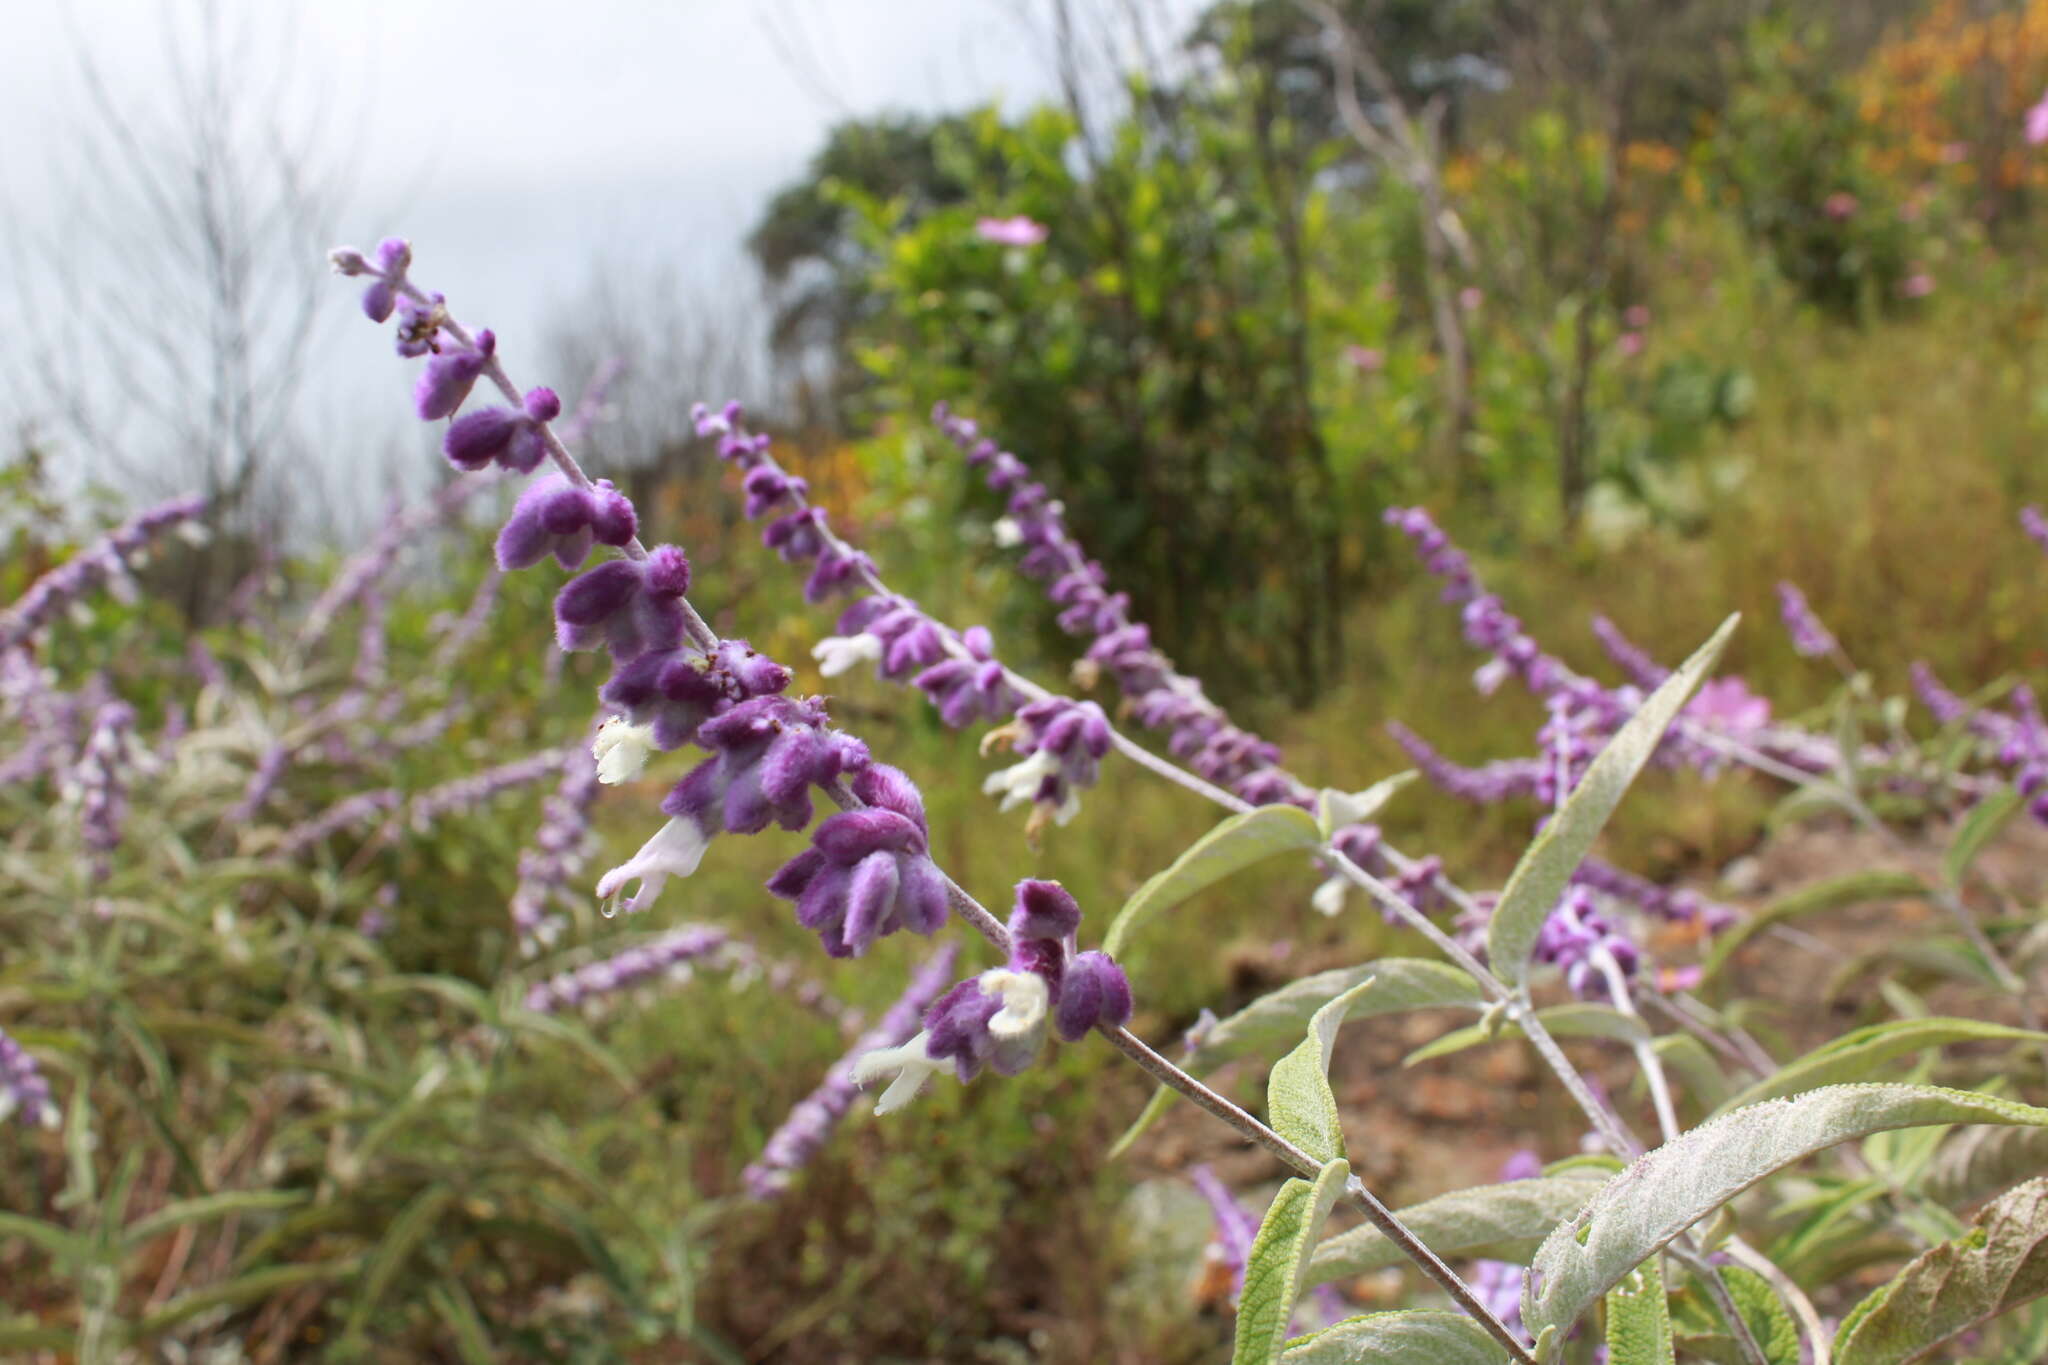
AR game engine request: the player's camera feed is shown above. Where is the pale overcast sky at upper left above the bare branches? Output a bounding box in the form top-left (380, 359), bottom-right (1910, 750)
top-left (0, 0), bottom-right (1192, 517)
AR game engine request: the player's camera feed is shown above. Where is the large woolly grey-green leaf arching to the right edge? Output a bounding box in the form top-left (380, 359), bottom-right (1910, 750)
top-left (1522, 1085), bottom-right (2048, 1349)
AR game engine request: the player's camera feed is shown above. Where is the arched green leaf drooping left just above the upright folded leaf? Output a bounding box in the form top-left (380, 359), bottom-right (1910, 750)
top-left (1110, 958), bottom-right (1487, 1158)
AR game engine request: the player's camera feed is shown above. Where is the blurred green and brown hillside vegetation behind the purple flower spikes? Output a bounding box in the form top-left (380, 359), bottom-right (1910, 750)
top-left (12, 0), bottom-right (2048, 1361)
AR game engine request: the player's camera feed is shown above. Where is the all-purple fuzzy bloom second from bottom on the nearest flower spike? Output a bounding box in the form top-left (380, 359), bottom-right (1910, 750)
top-left (768, 763), bottom-right (948, 958)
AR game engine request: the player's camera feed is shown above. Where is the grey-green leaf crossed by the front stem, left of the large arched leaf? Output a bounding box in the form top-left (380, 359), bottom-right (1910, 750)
top-left (1303, 1164), bottom-right (1614, 1293)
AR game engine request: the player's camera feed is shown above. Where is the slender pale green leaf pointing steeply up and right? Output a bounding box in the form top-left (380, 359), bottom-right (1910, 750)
top-left (1487, 616), bottom-right (1741, 986)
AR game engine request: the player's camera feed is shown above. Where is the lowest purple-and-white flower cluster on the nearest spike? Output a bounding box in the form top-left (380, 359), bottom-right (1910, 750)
top-left (854, 880), bottom-right (1130, 1113)
